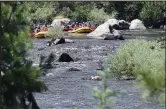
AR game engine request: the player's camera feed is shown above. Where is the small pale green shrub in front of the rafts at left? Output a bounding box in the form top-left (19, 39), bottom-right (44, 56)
top-left (45, 27), bottom-right (64, 38)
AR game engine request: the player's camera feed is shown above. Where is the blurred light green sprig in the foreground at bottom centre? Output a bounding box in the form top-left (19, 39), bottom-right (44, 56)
top-left (92, 71), bottom-right (117, 109)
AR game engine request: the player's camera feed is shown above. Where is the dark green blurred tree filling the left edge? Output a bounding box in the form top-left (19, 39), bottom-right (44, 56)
top-left (0, 2), bottom-right (47, 109)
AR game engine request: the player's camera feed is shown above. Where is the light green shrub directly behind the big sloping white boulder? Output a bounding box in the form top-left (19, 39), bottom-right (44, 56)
top-left (87, 7), bottom-right (115, 24)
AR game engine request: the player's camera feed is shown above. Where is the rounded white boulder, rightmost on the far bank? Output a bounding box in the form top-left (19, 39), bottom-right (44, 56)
top-left (129, 19), bottom-right (146, 30)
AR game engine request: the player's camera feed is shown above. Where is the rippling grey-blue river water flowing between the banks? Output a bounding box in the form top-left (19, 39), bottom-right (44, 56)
top-left (28, 29), bottom-right (165, 109)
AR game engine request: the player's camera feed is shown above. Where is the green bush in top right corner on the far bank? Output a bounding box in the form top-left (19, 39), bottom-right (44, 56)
top-left (140, 1), bottom-right (165, 26)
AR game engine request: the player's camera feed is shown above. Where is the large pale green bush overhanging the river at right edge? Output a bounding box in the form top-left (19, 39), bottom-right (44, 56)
top-left (107, 40), bottom-right (165, 103)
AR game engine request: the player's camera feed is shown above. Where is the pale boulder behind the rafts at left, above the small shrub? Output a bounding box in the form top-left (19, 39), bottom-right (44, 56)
top-left (51, 18), bottom-right (70, 27)
